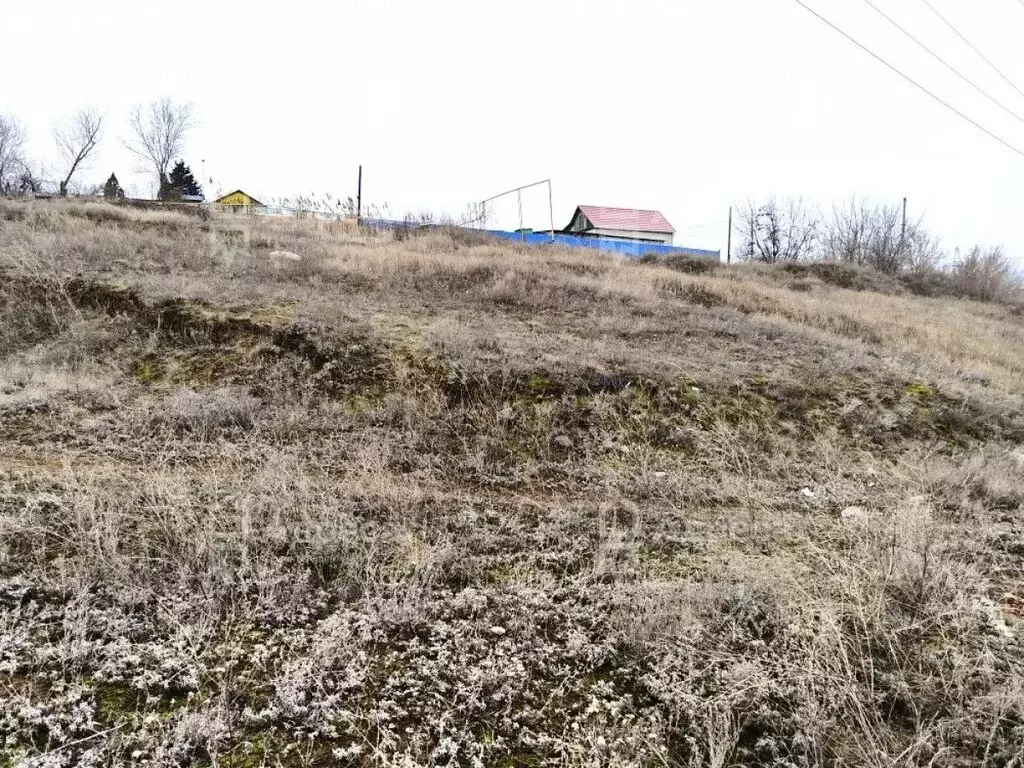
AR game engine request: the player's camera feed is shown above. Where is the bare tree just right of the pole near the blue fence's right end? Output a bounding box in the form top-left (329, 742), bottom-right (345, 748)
top-left (735, 198), bottom-right (820, 264)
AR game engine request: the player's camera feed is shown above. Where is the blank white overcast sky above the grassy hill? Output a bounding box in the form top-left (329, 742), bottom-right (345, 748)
top-left (6, 0), bottom-right (1024, 259)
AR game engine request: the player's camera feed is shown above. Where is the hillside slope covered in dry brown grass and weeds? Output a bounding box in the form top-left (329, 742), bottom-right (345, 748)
top-left (0, 201), bottom-right (1024, 767)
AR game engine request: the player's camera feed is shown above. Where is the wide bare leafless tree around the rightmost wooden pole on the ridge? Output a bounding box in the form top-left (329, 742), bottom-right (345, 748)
top-left (824, 198), bottom-right (940, 274)
